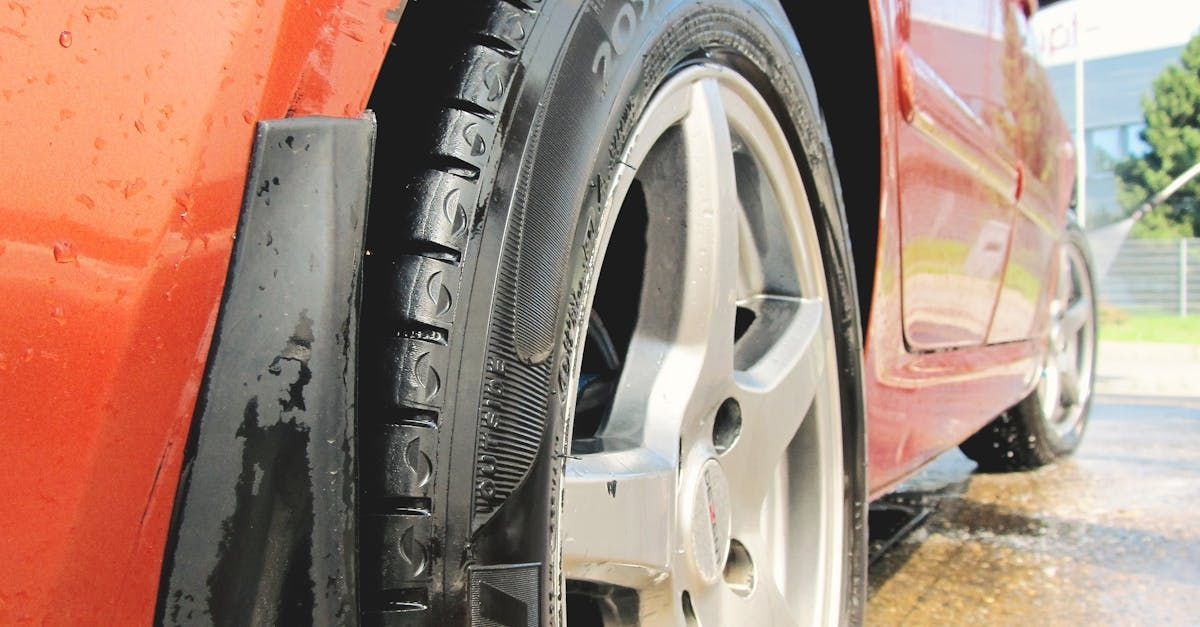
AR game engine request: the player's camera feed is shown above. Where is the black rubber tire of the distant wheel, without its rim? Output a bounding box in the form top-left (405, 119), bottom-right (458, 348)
top-left (959, 221), bottom-right (1099, 472)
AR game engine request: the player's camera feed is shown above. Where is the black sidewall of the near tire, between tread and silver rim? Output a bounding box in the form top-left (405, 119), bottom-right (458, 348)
top-left (444, 0), bottom-right (866, 623)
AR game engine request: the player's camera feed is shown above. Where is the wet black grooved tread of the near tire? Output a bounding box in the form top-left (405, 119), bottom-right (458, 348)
top-left (359, 0), bottom-right (542, 625)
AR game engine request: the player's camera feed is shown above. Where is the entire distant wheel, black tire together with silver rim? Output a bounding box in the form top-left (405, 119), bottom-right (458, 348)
top-left (960, 222), bottom-right (1097, 472)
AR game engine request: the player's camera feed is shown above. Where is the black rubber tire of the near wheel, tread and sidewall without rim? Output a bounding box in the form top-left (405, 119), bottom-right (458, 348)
top-left (358, 0), bottom-right (866, 625)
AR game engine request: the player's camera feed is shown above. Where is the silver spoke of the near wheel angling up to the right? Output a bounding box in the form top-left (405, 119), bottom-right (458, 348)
top-left (721, 299), bottom-right (828, 504)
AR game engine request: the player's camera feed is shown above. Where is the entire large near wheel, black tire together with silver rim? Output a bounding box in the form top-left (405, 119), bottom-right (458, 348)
top-left (359, 0), bottom-right (865, 625)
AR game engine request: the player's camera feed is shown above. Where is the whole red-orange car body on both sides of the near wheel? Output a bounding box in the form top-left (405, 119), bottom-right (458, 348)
top-left (0, 0), bottom-right (1073, 625)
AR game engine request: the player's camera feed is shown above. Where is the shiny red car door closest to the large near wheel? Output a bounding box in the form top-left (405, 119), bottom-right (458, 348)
top-left (895, 0), bottom-right (1019, 351)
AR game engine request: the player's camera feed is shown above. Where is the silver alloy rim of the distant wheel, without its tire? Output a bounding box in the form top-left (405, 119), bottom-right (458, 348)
top-left (1037, 237), bottom-right (1096, 440)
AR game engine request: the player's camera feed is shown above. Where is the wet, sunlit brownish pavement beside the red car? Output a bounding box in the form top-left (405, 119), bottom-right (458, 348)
top-left (868, 386), bottom-right (1200, 626)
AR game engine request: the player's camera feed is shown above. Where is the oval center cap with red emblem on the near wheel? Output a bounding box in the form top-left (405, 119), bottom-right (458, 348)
top-left (690, 459), bottom-right (732, 584)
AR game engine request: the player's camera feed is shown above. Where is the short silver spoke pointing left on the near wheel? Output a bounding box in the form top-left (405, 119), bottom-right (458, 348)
top-left (563, 448), bottom-right (676, 587)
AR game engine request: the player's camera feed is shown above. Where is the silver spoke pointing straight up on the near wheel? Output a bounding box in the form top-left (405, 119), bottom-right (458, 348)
top-left (608, 79), bottom-right (738, 455)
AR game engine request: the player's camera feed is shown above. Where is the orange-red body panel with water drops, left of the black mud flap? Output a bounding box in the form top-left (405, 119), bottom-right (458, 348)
top-left (0, 0), bottom-right (403, 625)
